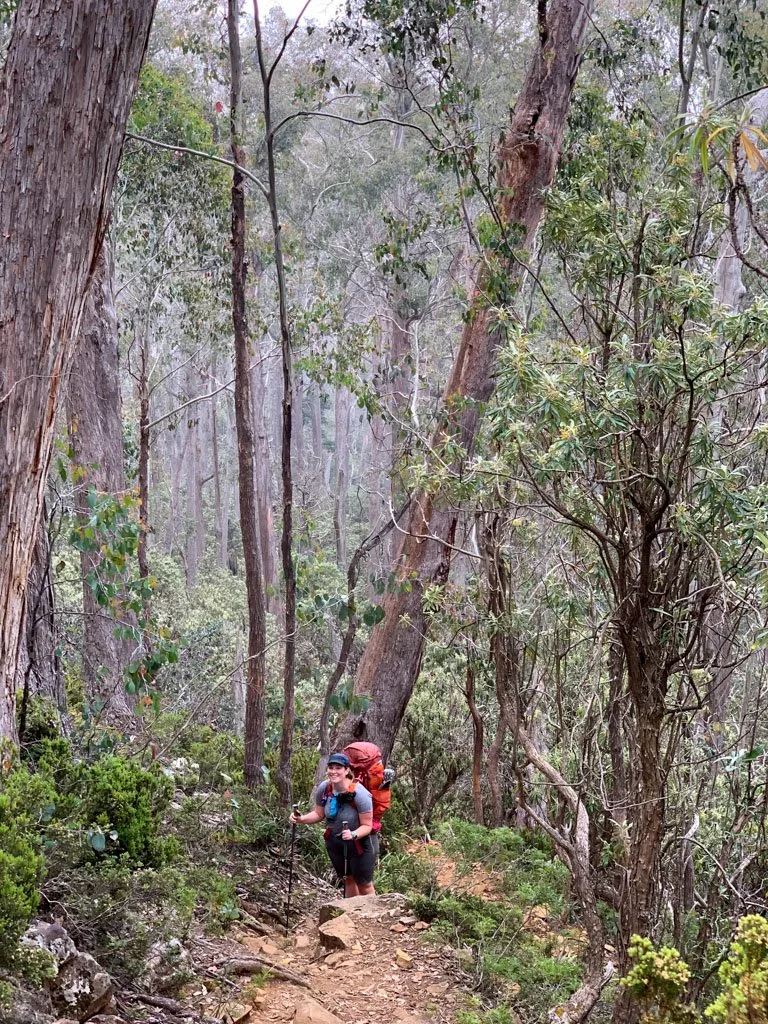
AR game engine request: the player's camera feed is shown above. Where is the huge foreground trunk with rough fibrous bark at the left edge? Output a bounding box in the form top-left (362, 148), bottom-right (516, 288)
top-left (0, 0), bottom-right (155, 739)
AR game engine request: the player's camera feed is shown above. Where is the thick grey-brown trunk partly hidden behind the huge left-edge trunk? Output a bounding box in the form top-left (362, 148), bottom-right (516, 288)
top-left (66, 243), bottom-right (136, 717)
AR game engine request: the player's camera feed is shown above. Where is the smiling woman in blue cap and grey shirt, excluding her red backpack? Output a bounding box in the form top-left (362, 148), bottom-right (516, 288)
top-left (291, 754), bottom-right (376, 897)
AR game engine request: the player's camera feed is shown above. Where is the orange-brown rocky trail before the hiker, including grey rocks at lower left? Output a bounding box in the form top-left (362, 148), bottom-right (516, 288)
top-left (12, 851), bottom-right (477, 1024)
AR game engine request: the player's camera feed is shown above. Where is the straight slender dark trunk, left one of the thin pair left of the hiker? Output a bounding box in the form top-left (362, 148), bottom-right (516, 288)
top-left (227, 0), bottom-right (266, 788)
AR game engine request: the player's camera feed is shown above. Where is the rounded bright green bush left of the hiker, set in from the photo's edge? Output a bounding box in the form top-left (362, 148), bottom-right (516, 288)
top-left (81, 757), bottom-right (176, 866)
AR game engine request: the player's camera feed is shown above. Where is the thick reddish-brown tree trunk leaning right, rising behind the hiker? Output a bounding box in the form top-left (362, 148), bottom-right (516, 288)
top-left (335, 0), bottom-right (593, 755)
